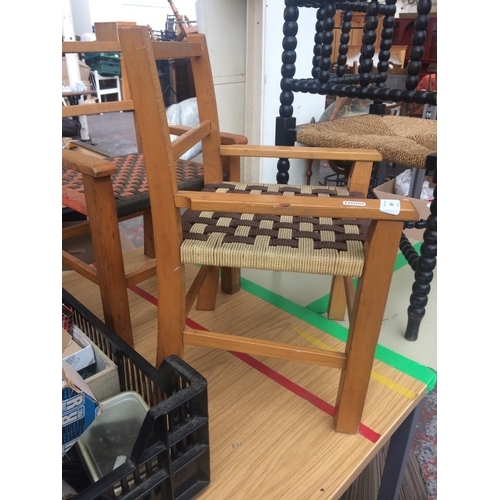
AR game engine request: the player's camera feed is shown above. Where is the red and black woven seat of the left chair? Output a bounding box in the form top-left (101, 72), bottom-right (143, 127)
top-left (62, 153), bottom-right (204, 218)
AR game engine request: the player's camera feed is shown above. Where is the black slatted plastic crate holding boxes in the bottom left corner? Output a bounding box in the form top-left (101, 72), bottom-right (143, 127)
top-left (62, 289), bottom-right (210, 500)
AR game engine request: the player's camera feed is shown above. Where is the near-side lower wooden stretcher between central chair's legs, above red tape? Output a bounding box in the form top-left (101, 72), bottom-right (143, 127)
top-left (184, 330), bottom-right (345, 368)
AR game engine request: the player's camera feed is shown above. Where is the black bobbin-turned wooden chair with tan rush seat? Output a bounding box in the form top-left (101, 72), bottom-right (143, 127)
top-left (275, 0), bottom-right (437, 341)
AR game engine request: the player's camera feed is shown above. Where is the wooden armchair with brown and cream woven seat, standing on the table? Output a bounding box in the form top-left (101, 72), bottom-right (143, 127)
top-left (112, 27), bottom-right (418, 433)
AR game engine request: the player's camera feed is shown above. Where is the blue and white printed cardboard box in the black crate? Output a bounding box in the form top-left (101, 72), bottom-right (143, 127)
top-left (62, 361), bottom-right (101, 456)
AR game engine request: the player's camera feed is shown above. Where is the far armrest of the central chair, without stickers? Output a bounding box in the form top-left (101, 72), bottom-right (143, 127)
top-left (220, 144), bottom-right (382, 161)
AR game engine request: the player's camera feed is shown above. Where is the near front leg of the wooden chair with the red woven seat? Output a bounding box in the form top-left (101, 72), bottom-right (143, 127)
top-left (83, 175), bottom-right (134, 347)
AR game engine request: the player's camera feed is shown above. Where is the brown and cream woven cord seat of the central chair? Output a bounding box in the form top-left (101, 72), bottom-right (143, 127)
top-left (181, 182), bottom-right (369, 276)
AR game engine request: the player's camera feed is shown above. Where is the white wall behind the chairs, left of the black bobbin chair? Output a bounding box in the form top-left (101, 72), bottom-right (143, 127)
top-left (197, 0), bottom-right (325, 183)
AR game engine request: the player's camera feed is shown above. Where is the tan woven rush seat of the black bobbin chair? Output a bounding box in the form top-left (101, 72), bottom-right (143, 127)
top-left (297, 115), bottom-right (437, 169)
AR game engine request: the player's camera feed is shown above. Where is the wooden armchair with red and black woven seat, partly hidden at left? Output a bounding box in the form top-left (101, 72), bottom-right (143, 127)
top-left (62, 41), bottom-right (246, 346)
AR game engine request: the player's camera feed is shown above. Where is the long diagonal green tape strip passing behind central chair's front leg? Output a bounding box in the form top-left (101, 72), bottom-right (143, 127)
top-left (241, 278), bottom-right (437, 391)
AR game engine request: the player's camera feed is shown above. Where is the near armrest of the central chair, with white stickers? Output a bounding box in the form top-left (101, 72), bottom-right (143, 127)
top-left (175, 191), bottom-right (420, 222)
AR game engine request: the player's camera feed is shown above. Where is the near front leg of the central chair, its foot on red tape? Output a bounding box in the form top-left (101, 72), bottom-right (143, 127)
top-left (334, 221), bottom-right (403, 434)
